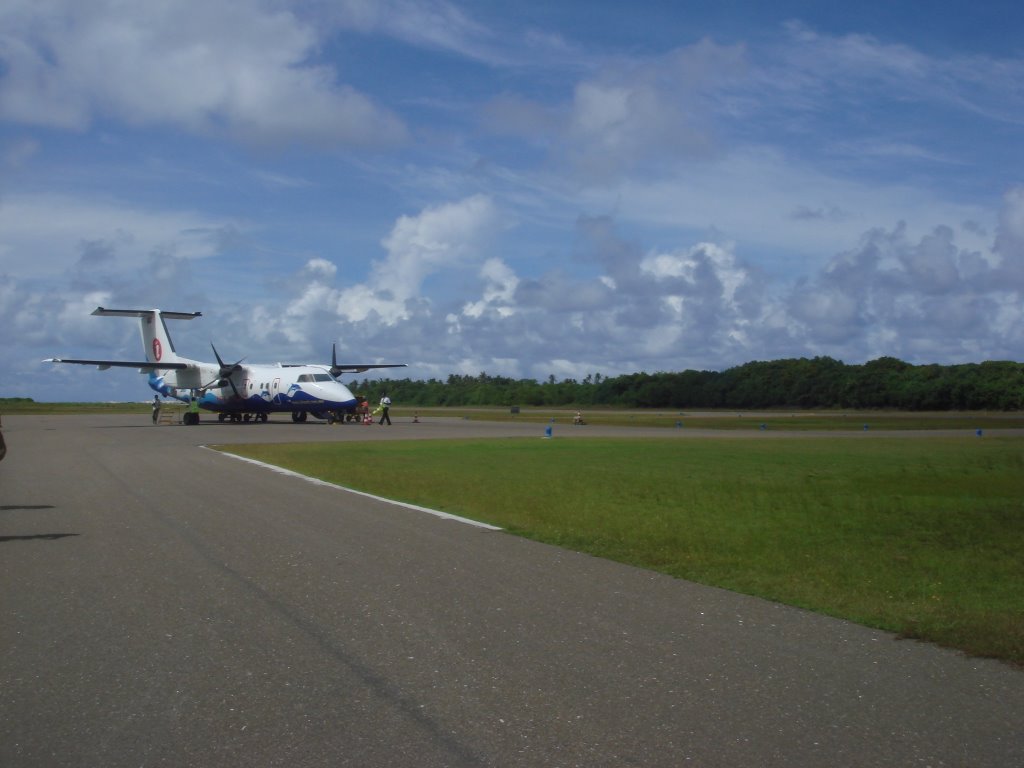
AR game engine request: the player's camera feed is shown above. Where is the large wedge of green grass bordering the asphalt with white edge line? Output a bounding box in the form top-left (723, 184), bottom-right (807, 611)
top-left (218, 435), bottom-right (1024, 664)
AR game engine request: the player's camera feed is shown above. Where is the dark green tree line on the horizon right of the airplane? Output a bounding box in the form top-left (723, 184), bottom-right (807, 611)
top-left (350, 357), bottom-right (1024, 411)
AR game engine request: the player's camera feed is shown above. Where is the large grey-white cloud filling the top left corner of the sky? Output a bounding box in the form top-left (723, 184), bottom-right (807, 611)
top-left (0, 0), bottom-right (406, 146)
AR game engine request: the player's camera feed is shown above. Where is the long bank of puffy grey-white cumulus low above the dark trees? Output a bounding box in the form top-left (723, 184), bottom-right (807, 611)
top-left (434, 190), bottom-right (1024, 378)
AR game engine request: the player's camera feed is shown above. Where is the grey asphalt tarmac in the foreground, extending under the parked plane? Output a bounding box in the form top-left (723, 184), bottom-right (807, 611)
top-left (0, 415), bottom-right (1024, 768)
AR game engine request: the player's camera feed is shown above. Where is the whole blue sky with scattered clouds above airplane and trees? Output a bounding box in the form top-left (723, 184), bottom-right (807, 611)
top-left (0, 0), bottom-right (1024, 401)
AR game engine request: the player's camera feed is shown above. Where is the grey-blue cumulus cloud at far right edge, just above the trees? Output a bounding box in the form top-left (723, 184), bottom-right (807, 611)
top-left (788, 189), bottom-right (1024, 360)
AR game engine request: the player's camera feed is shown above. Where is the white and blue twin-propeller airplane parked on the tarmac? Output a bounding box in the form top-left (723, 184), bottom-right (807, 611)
top-left (43, 307), bottom-right (407, 424)
